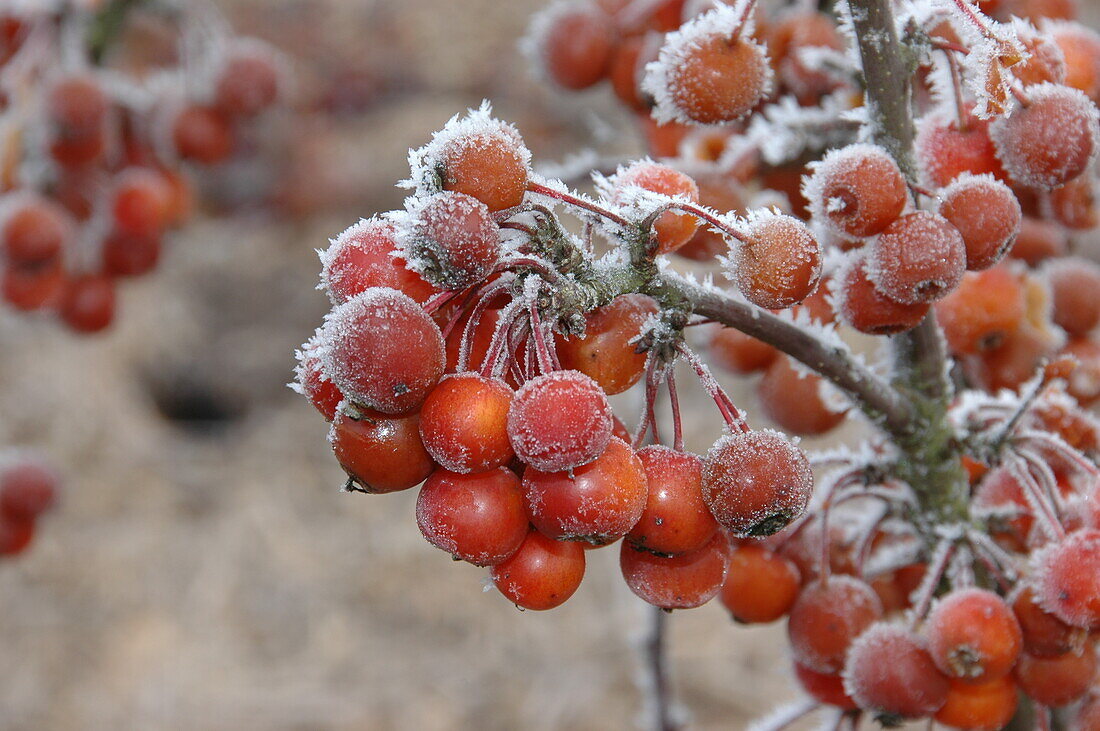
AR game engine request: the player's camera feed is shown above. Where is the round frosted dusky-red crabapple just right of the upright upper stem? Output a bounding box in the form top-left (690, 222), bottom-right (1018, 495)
top-left (867, 211), bottom-right (967, 304)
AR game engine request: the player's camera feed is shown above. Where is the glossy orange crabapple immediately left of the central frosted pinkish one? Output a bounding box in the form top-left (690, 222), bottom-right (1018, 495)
top-left (420, 373), bottom-right (516, 473)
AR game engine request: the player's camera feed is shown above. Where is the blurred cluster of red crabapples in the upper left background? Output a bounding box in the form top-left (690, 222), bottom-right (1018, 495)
top-left (0, 3), bottom-right (282, 333)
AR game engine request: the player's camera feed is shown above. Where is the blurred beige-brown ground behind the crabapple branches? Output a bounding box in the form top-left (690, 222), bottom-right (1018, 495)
top-left (0, 0), bottom-right (1091, 730)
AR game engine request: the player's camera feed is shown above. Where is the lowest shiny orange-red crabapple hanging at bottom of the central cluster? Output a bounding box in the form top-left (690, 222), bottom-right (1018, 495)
top-left (490, 530), bottom-right (585, 611)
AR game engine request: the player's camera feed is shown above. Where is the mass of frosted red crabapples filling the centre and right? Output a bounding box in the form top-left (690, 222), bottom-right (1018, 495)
top-left (296, 0), bottom-right (1100, 730)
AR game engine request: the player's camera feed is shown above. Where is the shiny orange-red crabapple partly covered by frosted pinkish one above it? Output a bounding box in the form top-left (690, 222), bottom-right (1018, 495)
top-left (523, 436), bottom-right (648, 545)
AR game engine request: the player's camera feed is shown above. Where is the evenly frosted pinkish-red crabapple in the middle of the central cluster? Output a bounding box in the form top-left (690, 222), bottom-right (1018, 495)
top-left (508, 370), bottom-right (612, 472)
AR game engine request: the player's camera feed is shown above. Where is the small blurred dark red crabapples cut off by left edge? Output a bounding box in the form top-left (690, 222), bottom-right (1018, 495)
top-left (0, 453), bottom-right (58, 556)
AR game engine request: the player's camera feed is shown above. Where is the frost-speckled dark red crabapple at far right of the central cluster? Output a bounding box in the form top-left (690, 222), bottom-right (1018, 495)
top-left (703, 431), bottom-right (813, 538)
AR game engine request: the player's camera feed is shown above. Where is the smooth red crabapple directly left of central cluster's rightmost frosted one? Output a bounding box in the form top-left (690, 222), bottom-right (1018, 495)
top-left (626, 444), bottom-right (718, 555)
